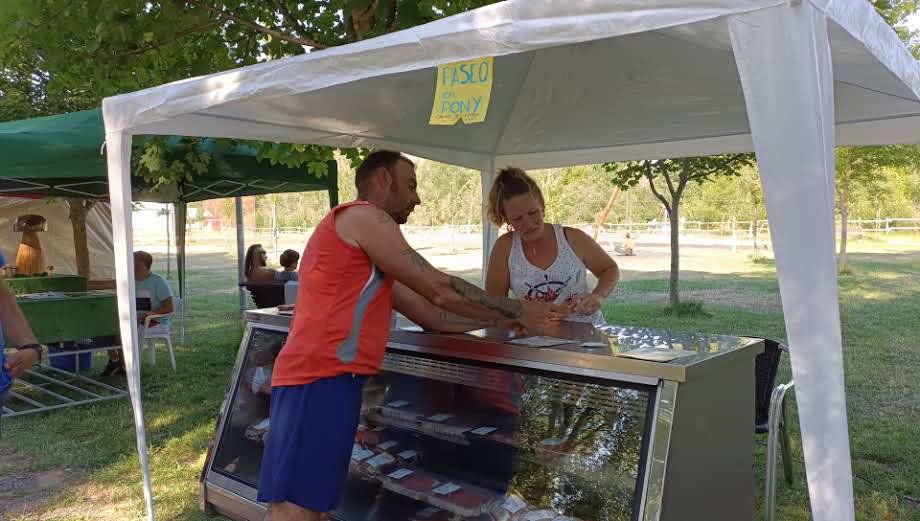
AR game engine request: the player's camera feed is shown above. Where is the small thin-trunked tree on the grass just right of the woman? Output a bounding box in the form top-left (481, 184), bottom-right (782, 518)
top-left (604, 154), bottom-right (754, 311)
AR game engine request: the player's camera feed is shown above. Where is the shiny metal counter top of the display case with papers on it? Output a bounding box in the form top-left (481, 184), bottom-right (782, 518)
top-left (246, 308), bottom-right (763, 385)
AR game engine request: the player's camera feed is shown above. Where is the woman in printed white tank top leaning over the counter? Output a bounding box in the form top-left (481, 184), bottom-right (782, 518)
top-left (486, 168), bottom-right (620, 326)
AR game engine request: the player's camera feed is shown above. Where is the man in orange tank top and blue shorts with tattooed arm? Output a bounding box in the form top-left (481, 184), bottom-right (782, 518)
top-left (258, 150), bottom-right (550, 521)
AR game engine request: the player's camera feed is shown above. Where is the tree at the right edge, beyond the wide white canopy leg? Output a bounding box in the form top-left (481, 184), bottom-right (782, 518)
top-left (836, 145), bottom-right (920, 273)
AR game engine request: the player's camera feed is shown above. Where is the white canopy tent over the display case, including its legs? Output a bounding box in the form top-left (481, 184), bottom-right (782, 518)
top-left (103, 0), bottom-right (920, 521)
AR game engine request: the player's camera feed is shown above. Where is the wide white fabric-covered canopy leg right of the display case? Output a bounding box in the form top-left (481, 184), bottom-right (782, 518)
top-left (729, 2), bottom-right (854, 521)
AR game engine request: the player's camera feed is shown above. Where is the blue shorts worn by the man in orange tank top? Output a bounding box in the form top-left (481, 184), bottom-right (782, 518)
top-left (258, 374), bottom-right (367, 512)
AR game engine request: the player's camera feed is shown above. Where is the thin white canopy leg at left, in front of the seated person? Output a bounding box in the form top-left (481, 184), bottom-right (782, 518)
top-left (105, 132), bottom-right (155, 521)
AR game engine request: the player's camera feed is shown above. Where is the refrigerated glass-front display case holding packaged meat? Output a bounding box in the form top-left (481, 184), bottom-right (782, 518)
top-left (202, 310), bottom-right (763, 521)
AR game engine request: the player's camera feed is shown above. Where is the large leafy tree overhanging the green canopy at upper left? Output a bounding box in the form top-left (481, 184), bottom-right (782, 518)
top-left (0, 0), bottom-right (504, 183)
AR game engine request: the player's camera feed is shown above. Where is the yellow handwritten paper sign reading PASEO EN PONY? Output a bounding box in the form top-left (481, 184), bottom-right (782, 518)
top-left (428, 57), bottom-right (495, 125)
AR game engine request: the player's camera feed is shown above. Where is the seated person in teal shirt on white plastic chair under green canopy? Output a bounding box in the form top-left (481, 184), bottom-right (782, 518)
top-left (101, 251), bottom-right (174, 376)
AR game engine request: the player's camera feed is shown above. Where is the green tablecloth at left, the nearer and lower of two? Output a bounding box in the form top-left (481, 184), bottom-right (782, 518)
top-left (16, 293), bottom-right (119, 344)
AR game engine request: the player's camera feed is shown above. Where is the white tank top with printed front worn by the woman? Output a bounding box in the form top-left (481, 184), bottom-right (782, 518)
top-left (508, 224), bottom-right (606, 326)
